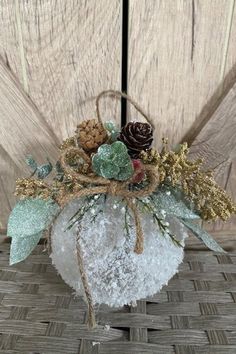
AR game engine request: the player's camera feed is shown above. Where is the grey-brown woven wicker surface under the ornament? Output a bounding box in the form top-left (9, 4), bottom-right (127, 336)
top-left (0, 239), bottom-right (236, 354)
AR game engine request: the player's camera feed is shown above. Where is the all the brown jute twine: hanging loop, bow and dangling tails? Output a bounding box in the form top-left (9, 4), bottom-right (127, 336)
top-left (60, 90), bottom-right (159, 327)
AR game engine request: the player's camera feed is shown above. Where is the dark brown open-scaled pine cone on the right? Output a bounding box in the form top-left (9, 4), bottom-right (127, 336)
top-left (118, 122), bottom-right (153, 158)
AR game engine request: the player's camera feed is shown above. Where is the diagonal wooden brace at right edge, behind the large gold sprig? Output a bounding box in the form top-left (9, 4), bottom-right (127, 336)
top-left (190, 84), bottom-right (236, 236)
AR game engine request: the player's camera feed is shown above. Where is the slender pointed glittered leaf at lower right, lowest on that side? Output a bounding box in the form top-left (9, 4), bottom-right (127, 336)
top-left (180, 219), bottom-right (226, 253)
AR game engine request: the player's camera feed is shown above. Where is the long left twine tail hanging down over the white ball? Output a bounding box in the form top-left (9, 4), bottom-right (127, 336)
top-left (76, 230), bottom-right (97, 329)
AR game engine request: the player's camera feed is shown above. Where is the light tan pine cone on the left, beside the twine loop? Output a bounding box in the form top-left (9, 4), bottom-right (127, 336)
top-left (76, 119), bottom-right (107, 151)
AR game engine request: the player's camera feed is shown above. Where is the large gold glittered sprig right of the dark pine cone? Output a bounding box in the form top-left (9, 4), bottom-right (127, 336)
top-left (141, 140), bottom-right (236, 220)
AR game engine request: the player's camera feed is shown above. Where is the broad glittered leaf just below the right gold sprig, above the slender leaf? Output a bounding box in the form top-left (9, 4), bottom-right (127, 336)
top-left (153, 187), bottom-right (199, 219)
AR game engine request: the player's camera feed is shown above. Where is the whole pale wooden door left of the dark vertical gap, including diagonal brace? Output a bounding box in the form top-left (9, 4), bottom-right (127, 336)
top-left (0, 0), bottom-right (121, 225)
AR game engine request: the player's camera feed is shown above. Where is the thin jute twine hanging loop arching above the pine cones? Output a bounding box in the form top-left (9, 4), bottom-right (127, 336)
top-left (96, 90), bottom-right (155, 130)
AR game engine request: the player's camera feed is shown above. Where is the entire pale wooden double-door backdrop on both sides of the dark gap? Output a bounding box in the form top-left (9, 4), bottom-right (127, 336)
top-left (0, 0), bottom-right (236, 249)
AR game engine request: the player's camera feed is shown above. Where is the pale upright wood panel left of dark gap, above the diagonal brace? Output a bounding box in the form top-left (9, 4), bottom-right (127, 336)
top-left (0, 0), bottom-right (121, 139)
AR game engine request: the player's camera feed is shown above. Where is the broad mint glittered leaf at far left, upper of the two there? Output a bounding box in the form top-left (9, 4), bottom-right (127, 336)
top-left (7, 198), bottom-right (59, 238)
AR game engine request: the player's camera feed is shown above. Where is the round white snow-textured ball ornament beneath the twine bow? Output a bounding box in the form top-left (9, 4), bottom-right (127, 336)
top-left (51, 197), bottom-right (187, 307)
